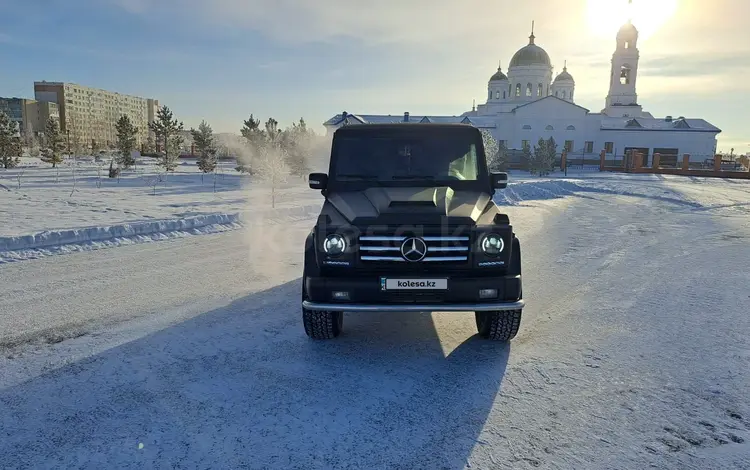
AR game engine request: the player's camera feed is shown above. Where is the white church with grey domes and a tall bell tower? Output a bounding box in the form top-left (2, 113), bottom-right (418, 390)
top-left (323, 22), bottom-right (721, 165)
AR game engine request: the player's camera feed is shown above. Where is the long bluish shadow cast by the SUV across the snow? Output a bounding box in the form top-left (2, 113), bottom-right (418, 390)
top-left (0, 280), bottom-right (510, 469)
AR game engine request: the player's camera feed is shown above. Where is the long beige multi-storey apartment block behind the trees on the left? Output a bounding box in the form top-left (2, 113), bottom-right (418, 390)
top-left (34, 81), bottom-right (159, 146)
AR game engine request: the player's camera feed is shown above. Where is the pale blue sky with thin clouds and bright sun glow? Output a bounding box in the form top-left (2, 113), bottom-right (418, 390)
top-left (0, 0), bottom-right (750, 153)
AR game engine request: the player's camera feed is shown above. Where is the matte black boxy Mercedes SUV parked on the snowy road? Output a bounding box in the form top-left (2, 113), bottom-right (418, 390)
top-left (302, 123), bottom-right (524, 341)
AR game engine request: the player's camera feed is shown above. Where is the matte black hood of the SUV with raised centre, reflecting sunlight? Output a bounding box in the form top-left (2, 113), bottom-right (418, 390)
top-left (323, 187), bottom-right (497, 226)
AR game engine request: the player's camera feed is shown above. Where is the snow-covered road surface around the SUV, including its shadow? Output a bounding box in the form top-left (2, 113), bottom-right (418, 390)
top-left (0, 180), bottom-right (750, 469)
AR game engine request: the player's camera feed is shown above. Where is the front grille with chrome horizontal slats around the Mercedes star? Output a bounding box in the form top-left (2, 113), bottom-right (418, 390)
top-left (359, 236), bottom-right (470, 264)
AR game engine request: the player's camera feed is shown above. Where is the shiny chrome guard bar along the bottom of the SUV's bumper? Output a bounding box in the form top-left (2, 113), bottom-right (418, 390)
top-left (302, 300), bottom-right (525, 313)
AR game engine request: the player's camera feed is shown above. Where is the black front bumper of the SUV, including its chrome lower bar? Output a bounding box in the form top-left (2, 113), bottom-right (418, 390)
top-left (303, 274), bottom-right (524, 312)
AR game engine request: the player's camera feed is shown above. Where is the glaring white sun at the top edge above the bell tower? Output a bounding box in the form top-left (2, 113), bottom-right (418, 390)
top-left (586, 0), bottom-right (678, 39)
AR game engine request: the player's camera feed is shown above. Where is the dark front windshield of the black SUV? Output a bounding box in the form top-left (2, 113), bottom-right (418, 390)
top-left (332, 131), bottom-right (480, 183)
